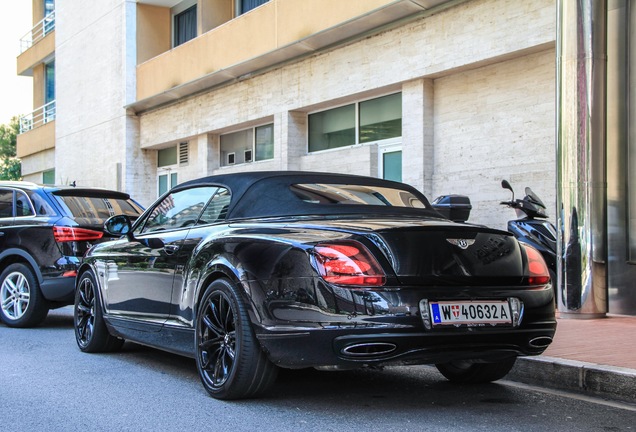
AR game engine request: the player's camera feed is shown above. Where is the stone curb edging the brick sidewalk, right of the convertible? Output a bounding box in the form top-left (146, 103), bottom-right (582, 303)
top-left (504, 356), bottom-right (636, 404)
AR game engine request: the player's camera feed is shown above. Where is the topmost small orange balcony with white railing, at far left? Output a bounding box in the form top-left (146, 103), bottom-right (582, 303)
top-left (17, 11), bottom-right (55, 76)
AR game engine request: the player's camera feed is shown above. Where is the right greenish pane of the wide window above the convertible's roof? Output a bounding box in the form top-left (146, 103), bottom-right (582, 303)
top-left (360, 93), bottom-right (402, 143)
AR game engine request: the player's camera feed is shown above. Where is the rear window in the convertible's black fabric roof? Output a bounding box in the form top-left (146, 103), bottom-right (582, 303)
top-left (290, 183), bottom-right (427, 209)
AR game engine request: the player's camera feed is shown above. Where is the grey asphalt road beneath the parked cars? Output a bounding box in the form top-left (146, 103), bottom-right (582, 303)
top-left (0, 307), bottom-right (636, 432)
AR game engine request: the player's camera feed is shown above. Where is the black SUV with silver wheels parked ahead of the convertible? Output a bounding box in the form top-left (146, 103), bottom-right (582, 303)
top-left (0, 181), bottom-right (143, 327)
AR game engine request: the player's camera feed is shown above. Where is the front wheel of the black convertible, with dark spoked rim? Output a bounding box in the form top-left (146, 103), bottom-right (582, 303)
top-left (73, 271), bottom-right (124, 353)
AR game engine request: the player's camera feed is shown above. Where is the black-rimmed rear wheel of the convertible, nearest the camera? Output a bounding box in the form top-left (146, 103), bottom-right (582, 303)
top-left (195, 279), bottom-right (278, 400)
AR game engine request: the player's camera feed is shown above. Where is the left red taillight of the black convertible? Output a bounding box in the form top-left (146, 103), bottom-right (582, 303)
top-left (314, 241), bottom-right (386, 286)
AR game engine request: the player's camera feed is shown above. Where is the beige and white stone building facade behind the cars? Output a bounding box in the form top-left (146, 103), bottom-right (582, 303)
top-left (18, 0), bottom-right (636, 314)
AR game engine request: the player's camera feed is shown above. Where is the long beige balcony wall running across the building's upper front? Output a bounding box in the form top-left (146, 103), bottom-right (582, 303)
top-left (128, 0), bottom-right (456, 113)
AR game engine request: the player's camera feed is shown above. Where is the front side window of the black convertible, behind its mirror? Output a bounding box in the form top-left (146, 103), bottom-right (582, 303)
top-left (143, 186), bottom-right (218, 232)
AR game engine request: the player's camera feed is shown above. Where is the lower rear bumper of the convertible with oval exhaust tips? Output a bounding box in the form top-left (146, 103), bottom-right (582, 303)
top-left (258, 320), bottom-right (556, 368)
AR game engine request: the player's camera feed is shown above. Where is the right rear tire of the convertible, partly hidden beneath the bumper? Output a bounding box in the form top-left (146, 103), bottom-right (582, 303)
top-left (435, 357), bottom-right (517, 383)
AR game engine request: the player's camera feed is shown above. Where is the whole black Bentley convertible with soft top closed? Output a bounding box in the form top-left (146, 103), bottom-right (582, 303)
top-left (74, 172), bottom-right (556, 399)
